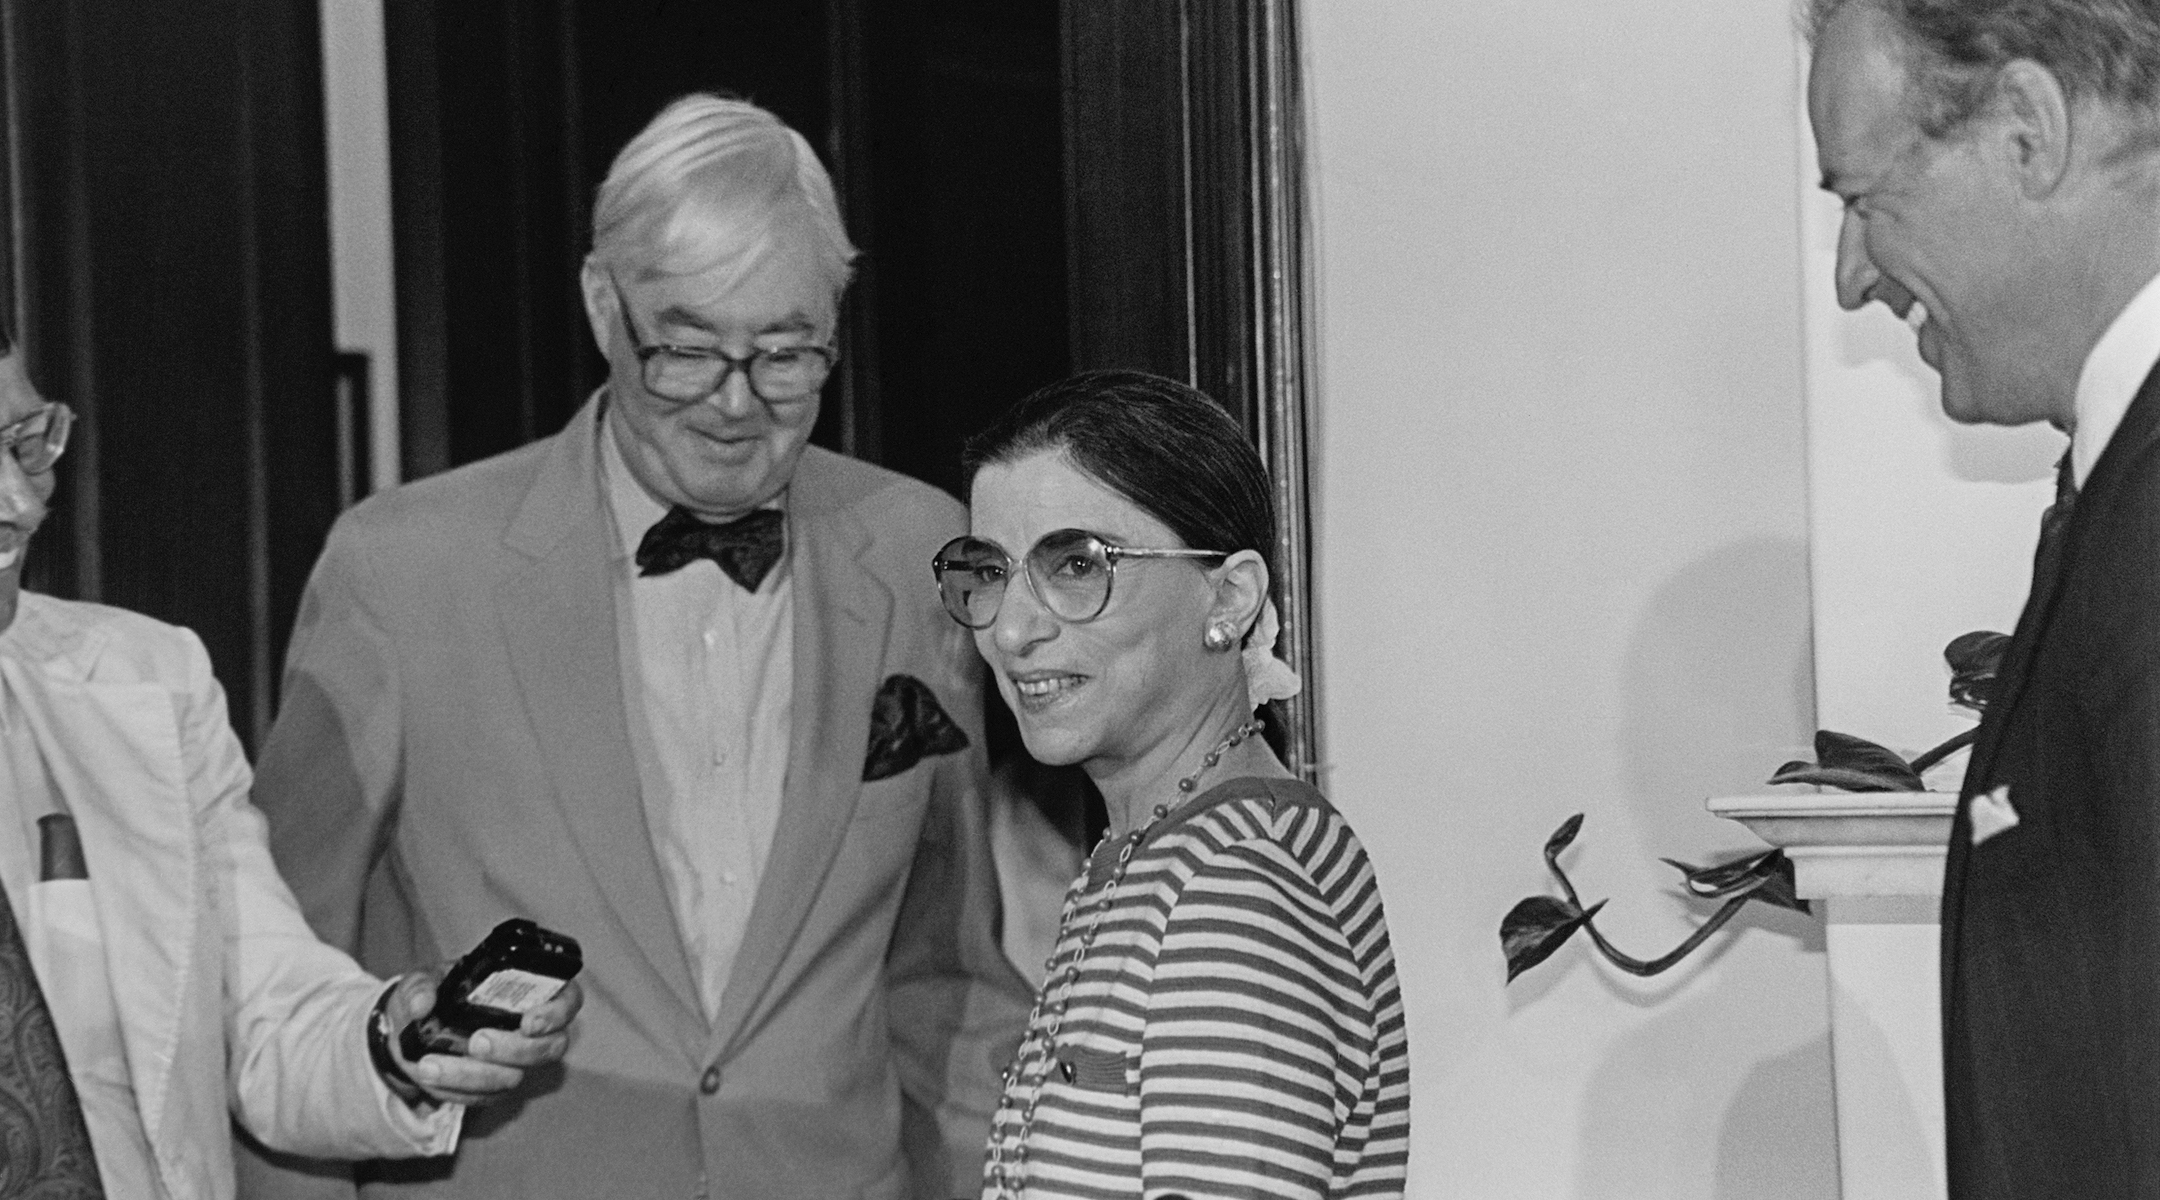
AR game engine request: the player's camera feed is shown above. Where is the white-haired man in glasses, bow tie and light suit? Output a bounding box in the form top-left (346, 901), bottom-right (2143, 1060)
top-left (240, 95), bottom-right (1028, 1200)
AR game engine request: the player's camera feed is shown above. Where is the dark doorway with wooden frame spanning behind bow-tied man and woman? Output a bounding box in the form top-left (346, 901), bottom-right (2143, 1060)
top-left (0, 0), bottom-right (1313, 768)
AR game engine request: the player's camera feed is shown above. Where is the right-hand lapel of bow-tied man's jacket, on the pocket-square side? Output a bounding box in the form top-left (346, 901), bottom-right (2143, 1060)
top-left (713, 451), bottom-right (892, 1049)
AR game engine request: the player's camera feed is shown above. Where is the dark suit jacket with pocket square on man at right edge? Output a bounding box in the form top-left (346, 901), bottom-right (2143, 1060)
top-left (1942, 360), bottom-right (2160, 1200)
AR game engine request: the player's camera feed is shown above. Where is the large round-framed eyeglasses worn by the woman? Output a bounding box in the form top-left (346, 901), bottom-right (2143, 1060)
top-left (931, 529), bottom-right (1229, 630)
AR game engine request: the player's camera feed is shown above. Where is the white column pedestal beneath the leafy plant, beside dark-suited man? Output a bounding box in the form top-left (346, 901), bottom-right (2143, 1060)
top-left (1709, 792), bottom-right (1957, 1200)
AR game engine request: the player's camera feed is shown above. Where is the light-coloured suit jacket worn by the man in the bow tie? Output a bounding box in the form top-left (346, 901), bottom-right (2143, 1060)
top-left (248, 404), bottom-right (1028, 1200)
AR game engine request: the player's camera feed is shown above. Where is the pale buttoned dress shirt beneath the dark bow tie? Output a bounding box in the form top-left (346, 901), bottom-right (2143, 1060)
top-left (598, 419), bottom-right (795, 1021)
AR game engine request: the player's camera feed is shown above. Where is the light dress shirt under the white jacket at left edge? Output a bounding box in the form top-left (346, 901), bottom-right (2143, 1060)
top-left (0, 624), bottom-right (166, 1200)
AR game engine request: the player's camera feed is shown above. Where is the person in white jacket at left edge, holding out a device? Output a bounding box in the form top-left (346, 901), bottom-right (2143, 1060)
top-left (0, 341), bottom-right (581, 1200)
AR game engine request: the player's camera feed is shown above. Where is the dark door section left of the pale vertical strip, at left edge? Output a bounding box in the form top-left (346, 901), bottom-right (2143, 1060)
top-left (0, 0), bottom-right (341, 747)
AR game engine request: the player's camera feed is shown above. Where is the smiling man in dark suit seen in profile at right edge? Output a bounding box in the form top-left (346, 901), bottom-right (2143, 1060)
top-left (1808, 0), bottom-right (2160, 1200)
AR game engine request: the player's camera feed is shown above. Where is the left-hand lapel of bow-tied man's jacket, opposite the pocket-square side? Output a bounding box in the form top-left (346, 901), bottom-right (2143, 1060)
top-left (497, 404), bottom-right (702, 1025)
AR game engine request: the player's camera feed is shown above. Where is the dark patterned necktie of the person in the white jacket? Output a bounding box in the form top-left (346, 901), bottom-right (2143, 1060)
top-left (0, 867), bottom-right (106, 1200)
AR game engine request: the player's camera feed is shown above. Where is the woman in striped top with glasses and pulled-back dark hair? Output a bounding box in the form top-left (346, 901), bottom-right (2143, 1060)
top-left (933, 371), bottom-right (1410, 1200)
